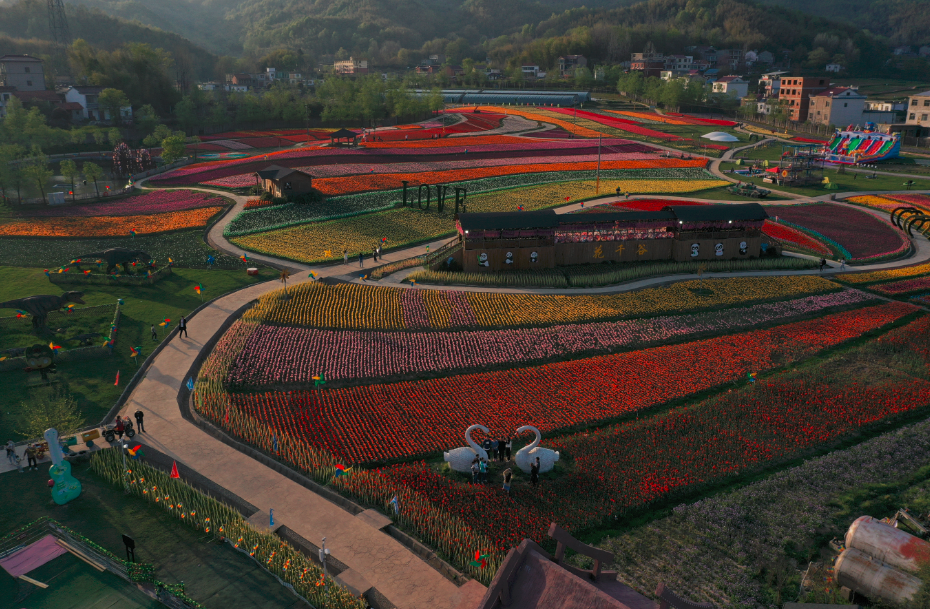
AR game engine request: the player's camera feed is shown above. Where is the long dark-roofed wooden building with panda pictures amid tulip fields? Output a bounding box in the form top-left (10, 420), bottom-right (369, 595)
top-left (456, 203), bottom-right (768, 272)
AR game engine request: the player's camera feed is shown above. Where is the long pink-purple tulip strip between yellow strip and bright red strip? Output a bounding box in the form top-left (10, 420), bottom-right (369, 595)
top-left (226, 290), bottom-right (873, 386)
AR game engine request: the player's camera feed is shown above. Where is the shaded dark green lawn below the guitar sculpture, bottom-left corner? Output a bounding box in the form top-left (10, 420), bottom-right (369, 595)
top-left (0, 463), bottom-right (307, 609)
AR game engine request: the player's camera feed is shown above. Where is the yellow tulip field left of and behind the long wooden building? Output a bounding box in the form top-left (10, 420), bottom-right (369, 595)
top-left (230, 179), bottom-right (726, 263)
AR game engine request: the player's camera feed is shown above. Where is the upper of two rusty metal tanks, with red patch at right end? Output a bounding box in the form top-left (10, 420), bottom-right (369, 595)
top-left (846, 516), bottom-right (930, 573)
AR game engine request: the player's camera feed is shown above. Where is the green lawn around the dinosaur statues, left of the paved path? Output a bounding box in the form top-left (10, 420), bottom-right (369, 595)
top-left (0, 266), bottom-right (277, 442)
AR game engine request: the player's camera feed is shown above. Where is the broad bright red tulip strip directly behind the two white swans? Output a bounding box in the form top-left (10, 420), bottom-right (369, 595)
top-left (206, 303), bottom-right (916, 463)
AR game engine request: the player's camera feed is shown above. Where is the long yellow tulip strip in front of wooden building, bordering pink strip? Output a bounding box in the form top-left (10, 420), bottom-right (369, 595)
top-left (243, 276), bottom-right (836, 330)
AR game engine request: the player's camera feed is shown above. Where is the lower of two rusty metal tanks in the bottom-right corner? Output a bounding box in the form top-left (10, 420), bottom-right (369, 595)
top-left (834, 548), bottom-right (923, 604)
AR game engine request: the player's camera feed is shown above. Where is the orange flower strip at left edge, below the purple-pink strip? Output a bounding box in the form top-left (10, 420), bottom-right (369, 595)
top-left (0, 207), bottom-right (223, 237)
